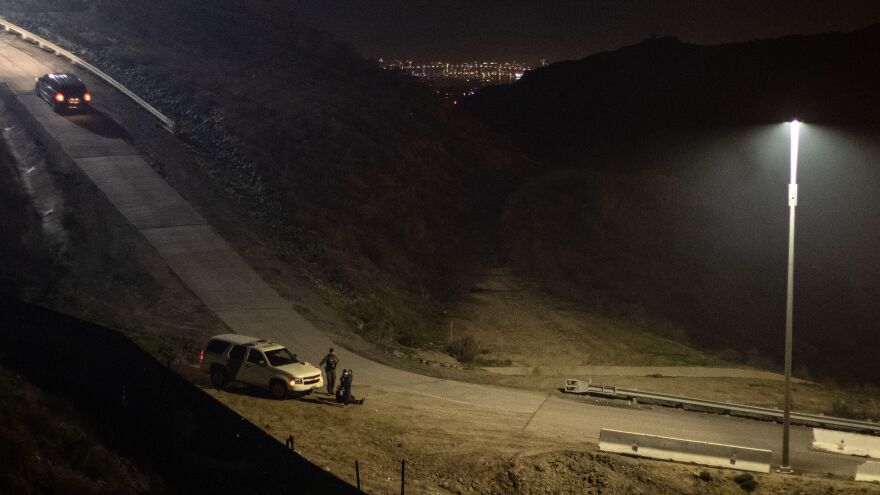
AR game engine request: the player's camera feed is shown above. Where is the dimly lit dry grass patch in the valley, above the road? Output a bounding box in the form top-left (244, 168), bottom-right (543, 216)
top-left (447, 268), bottom-right (722, 368)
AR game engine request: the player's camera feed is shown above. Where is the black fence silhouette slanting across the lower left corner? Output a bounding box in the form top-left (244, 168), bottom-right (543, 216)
top-left (0, 295), bottom-right (362, 495)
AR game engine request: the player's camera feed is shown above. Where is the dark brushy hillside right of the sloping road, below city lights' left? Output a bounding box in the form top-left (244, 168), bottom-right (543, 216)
top-left (0, 0), bottom-right (522, 341)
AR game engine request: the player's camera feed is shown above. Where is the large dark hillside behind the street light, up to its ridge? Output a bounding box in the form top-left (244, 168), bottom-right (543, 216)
top-left (465, 26), bottom-right (880, 382)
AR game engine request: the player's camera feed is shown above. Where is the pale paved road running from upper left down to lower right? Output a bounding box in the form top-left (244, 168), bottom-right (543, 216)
top-left (0, 37), bottom-right (868, 476)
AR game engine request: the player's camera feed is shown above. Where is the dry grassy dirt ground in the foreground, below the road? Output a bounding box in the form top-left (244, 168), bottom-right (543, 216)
top-left (207, 387), bottom-right (880, 495)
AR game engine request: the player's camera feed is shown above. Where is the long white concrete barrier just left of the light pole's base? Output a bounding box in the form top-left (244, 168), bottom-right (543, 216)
top-left (599, 429), bottom-right (772, 473)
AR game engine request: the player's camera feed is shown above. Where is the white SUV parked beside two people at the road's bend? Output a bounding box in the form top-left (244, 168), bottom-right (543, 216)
top-left (199, 333), bottom-right (324, 400)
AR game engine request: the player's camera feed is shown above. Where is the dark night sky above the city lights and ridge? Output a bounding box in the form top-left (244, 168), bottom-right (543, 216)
top-left (291, 0), bottom-right (880, 63)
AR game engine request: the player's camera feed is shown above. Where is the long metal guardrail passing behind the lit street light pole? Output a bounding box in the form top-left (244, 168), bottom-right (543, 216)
top-left (565, 379), bottom-right (880, 435)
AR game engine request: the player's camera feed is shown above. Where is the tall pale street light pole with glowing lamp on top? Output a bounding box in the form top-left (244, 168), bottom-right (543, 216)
top-left (779, 120), bottom-right (800, 472)
